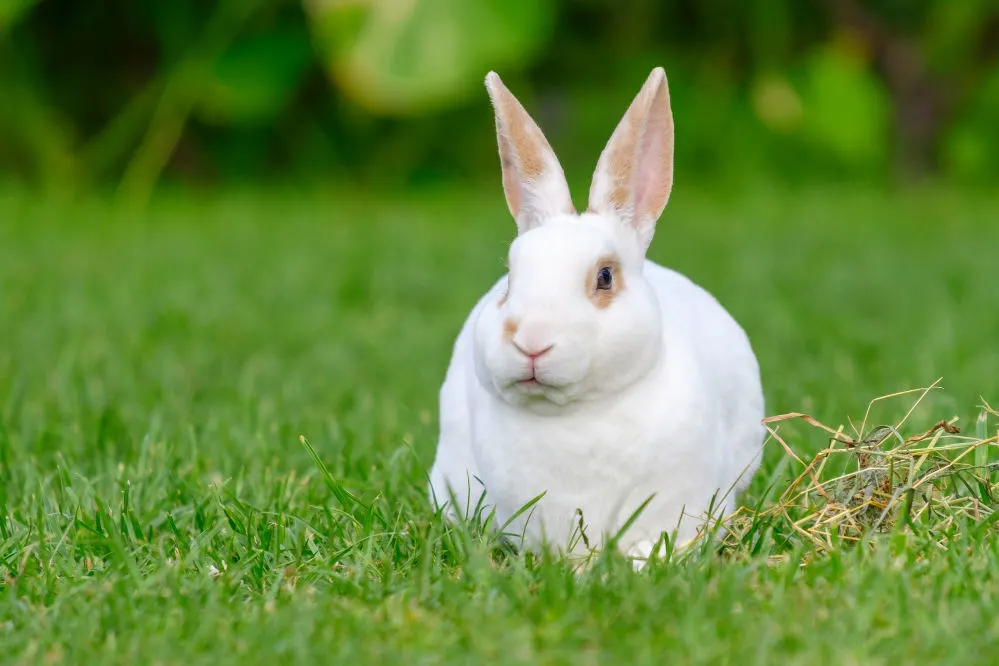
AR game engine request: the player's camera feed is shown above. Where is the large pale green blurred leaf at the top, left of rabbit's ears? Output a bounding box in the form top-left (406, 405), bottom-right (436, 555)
top-left (305, 0), bottom-right (554, 116)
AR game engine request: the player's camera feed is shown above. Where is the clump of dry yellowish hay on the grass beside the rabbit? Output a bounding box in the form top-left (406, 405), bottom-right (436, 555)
top-left (725, 381), bottom-right (999, 552)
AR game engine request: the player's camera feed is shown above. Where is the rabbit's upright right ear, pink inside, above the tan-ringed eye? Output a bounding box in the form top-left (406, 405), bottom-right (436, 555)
top-left (589, 67), bottom-right (673, 249)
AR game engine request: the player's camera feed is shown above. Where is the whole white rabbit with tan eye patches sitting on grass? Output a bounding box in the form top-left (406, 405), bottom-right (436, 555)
top-left (430, 68), bottom-right (764, 559)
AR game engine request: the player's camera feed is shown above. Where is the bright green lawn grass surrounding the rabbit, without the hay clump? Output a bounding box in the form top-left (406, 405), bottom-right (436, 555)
top-left (0, 183), bottom-right (999, 664)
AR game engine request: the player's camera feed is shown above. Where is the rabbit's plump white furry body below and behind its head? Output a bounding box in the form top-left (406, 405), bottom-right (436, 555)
top-left (431, 255), bottom-right (764, 557)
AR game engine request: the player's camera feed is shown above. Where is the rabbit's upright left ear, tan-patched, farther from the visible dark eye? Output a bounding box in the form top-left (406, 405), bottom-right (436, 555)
top-left (486, 72), bottom-right (576, 233)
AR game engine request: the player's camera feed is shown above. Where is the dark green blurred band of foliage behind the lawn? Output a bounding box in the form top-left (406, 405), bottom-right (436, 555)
top-left (0, 0), bottom-right (999, 202)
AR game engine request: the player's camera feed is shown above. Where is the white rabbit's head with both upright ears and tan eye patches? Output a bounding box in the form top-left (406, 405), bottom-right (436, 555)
top-left (475, 68), bottom-right (673, 409)
